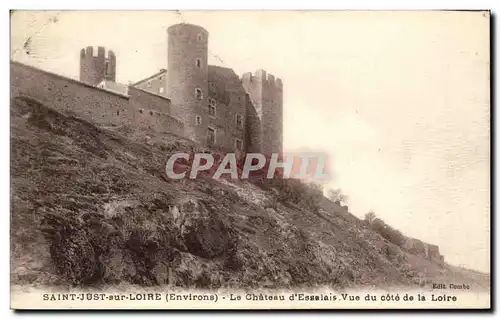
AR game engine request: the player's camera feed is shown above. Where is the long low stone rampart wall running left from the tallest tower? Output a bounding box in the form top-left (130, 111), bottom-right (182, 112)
top-left (10, 61), bottom-right (183, 136)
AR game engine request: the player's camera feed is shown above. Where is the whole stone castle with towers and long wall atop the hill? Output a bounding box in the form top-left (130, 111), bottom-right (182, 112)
top-left (11, 23), bottom-right (283, 154)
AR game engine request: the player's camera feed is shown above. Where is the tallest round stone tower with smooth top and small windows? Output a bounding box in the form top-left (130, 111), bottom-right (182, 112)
top-left (167, 23), bottom-right (208, 144)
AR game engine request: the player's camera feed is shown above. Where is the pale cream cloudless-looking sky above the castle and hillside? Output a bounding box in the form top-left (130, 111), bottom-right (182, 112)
top-left (11, 11), bottom-right (490, 271)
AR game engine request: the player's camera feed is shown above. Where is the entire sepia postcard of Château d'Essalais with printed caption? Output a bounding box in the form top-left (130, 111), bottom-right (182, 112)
top-left (9, 10), bottom-right (491, 309)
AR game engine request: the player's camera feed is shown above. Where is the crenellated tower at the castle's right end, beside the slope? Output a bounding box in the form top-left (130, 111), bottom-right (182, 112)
top-left (241, 70), bottom-right (283, 154)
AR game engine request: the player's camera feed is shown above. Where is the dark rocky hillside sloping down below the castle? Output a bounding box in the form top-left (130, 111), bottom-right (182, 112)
top-left (11, 100), bottom-right (489, 289)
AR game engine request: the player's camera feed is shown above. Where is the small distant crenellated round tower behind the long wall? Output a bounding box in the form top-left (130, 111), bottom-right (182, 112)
top-left (80, 46), bottom-right (116, 85)
